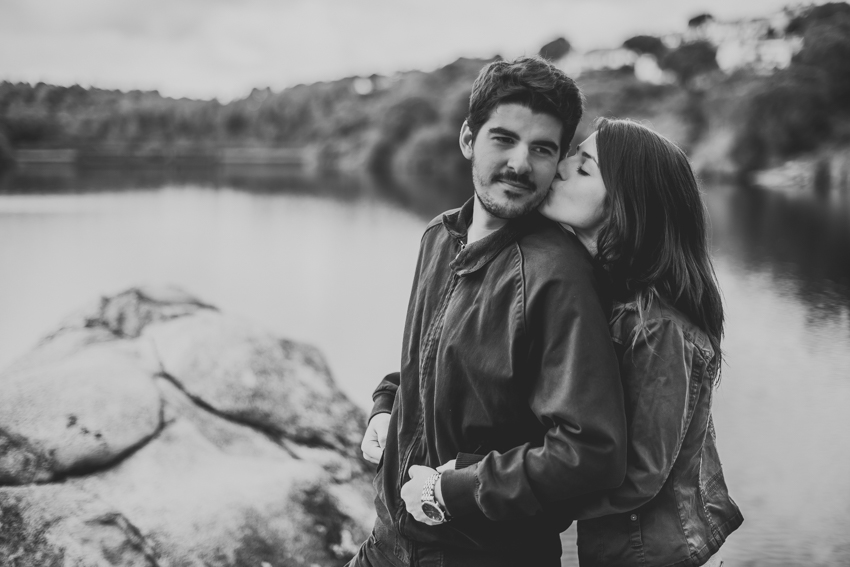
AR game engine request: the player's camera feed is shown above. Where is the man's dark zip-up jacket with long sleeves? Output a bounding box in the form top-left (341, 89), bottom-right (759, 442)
top-left (372, 200), bottom-right (626, 550)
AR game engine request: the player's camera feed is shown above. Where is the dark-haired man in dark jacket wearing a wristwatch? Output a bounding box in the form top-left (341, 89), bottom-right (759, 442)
top-left (351, 58), bottom-right (626, 567)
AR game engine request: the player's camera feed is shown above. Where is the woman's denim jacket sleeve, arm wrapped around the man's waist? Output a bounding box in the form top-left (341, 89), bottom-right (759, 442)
top-left (574, 319), bottom-right (707, 519)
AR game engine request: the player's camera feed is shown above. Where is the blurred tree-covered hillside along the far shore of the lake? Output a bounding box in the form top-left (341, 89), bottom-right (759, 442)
top-left (0, 2), bottom-right (850, 177)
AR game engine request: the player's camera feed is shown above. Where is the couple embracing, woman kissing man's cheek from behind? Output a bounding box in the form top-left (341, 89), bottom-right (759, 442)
top-left (350, 58), bottom-right (743, 567)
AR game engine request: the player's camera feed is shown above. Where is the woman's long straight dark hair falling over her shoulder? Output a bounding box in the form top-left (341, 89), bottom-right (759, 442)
top-left (596, 119), bottom-right (723, 370)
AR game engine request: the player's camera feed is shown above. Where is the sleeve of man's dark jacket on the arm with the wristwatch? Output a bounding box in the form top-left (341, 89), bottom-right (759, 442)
top-left (441, 262), bottom-right (626, 520)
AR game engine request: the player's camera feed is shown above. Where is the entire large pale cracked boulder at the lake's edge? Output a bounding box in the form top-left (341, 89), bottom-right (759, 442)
top-left (0, 289), bottom-right (374, 567)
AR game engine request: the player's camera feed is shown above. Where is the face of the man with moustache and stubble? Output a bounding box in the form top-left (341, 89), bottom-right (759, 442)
top-left (460, 104), bottom-right (563, 219)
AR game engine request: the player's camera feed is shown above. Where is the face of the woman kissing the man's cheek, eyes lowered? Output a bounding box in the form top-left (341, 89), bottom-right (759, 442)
top-left (540, 132), bottom-right (606, 239)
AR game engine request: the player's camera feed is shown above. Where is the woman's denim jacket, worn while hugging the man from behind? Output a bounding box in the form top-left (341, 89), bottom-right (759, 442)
top-left (576, 301), bottom-right (743, 567)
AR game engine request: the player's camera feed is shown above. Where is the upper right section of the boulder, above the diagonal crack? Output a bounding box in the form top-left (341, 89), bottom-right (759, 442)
top-left (143, 311), bottom-right (361, 456)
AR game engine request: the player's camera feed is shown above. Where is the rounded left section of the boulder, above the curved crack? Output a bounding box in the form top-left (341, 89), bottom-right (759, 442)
top-left (0, 342), bottom-right (161, 484)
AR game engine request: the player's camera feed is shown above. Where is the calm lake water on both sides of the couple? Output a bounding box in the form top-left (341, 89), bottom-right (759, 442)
top-left (0, 165), bottom-right (850, 566)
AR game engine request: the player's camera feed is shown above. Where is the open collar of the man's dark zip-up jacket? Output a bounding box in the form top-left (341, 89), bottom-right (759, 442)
top-left (443, 197), bottom-right (545, 276)
